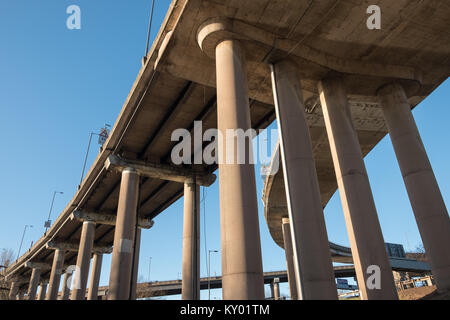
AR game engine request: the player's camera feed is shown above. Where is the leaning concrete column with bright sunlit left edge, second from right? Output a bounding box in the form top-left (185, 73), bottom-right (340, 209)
top-left (318, 78), bottom-right (398, 300)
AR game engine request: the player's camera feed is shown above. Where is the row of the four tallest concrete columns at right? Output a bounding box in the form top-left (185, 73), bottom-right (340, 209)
top-left (198, 23), bottom-right (450, 299)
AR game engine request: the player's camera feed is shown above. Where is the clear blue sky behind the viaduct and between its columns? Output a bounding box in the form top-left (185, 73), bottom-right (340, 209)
top-left (0, 0), bottom-right (450, 297)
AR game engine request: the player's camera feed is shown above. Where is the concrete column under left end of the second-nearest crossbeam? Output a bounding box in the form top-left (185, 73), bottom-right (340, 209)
top-left (70, 221), bottom-right (95, 300)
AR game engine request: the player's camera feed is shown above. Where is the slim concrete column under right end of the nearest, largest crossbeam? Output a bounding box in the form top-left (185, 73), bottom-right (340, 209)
top-left (181, 182), bottom-right (200, 300)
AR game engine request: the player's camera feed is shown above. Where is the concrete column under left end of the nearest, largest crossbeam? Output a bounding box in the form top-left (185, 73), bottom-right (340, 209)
top-left (108, 168), bottom-right (139, 300)
